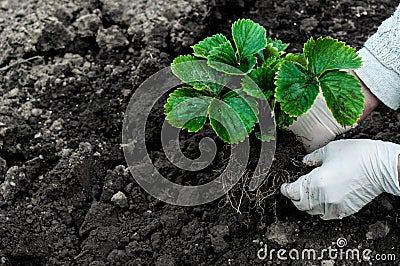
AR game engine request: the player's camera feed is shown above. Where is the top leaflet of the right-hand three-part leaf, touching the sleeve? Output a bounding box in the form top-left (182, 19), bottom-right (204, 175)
top-left (304, 37), bottom-right (362, 75)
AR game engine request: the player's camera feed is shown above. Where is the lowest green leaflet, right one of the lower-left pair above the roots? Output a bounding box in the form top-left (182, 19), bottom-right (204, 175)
top-left (208, 91), bottom-right (258, 144)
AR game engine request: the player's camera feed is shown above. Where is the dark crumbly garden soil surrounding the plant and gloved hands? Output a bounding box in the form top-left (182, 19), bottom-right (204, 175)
top-left (0, 0), bottom-right (400, 266)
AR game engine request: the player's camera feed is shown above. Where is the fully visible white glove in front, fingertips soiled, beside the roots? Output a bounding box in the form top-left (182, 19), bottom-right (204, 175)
top-left (281, 140), bottom-right (400, 220)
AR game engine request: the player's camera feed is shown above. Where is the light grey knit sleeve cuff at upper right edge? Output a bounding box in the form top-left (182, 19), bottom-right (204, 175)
top-left (355, 6), bottom-right (400, 109)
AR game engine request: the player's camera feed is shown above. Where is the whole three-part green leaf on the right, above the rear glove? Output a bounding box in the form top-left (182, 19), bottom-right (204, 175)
top-left (275, 37), bottom-right (363, 126)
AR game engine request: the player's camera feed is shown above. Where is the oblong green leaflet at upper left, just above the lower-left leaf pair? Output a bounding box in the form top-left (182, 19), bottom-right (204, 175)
top-left (171, 55), bottom-right (229, 96)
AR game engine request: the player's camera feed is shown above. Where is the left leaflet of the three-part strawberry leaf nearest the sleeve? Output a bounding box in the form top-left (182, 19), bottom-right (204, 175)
top-left (275, 61), bottom-right (319, 116)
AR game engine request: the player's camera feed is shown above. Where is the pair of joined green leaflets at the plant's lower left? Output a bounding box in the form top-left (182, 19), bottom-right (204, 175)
top-left (164, 87), bottom-right (258, 144)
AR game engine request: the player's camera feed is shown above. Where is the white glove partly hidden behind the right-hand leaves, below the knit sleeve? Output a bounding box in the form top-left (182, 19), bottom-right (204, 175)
top-left (289, 93), bottom-right (351, 152)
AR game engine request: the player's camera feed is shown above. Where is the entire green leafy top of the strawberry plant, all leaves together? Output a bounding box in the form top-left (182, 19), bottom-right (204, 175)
top-left (165, 19), bottom-right (364, 143)
